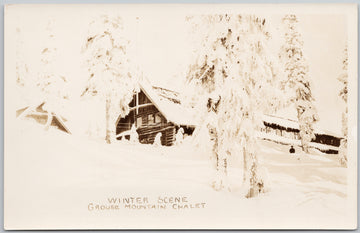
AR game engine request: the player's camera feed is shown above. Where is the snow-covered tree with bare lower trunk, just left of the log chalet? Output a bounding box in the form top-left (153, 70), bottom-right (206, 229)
top-left (83, 15), bottom-right (137, 143)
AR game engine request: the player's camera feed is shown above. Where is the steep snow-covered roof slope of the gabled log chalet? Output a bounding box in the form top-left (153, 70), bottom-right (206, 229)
top-left (140, 82), bottom-right (198, 126)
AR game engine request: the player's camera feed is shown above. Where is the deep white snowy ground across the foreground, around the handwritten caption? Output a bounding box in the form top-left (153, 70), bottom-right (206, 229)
top-left (5, 120), bottom-right (348, 229)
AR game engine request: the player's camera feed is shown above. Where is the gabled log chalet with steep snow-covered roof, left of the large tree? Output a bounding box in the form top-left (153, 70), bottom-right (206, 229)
top-left (116, 82), bottom-right (197, 146)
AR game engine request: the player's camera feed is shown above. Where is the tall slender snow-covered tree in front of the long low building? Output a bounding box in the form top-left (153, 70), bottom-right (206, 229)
top-left (280, 15), bottom-right (318, 152)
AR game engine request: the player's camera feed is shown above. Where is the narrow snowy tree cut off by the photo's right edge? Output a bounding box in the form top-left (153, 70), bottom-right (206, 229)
top-left (338, 46), bottom-right (348, 167)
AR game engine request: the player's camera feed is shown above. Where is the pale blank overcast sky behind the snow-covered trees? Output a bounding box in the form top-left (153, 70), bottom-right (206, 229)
top-left (5, 5), bottom-right (347, 133)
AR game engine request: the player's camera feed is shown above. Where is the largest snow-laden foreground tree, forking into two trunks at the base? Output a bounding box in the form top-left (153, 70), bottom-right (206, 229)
top-left (188, 15), bottom-right (281, 197)
